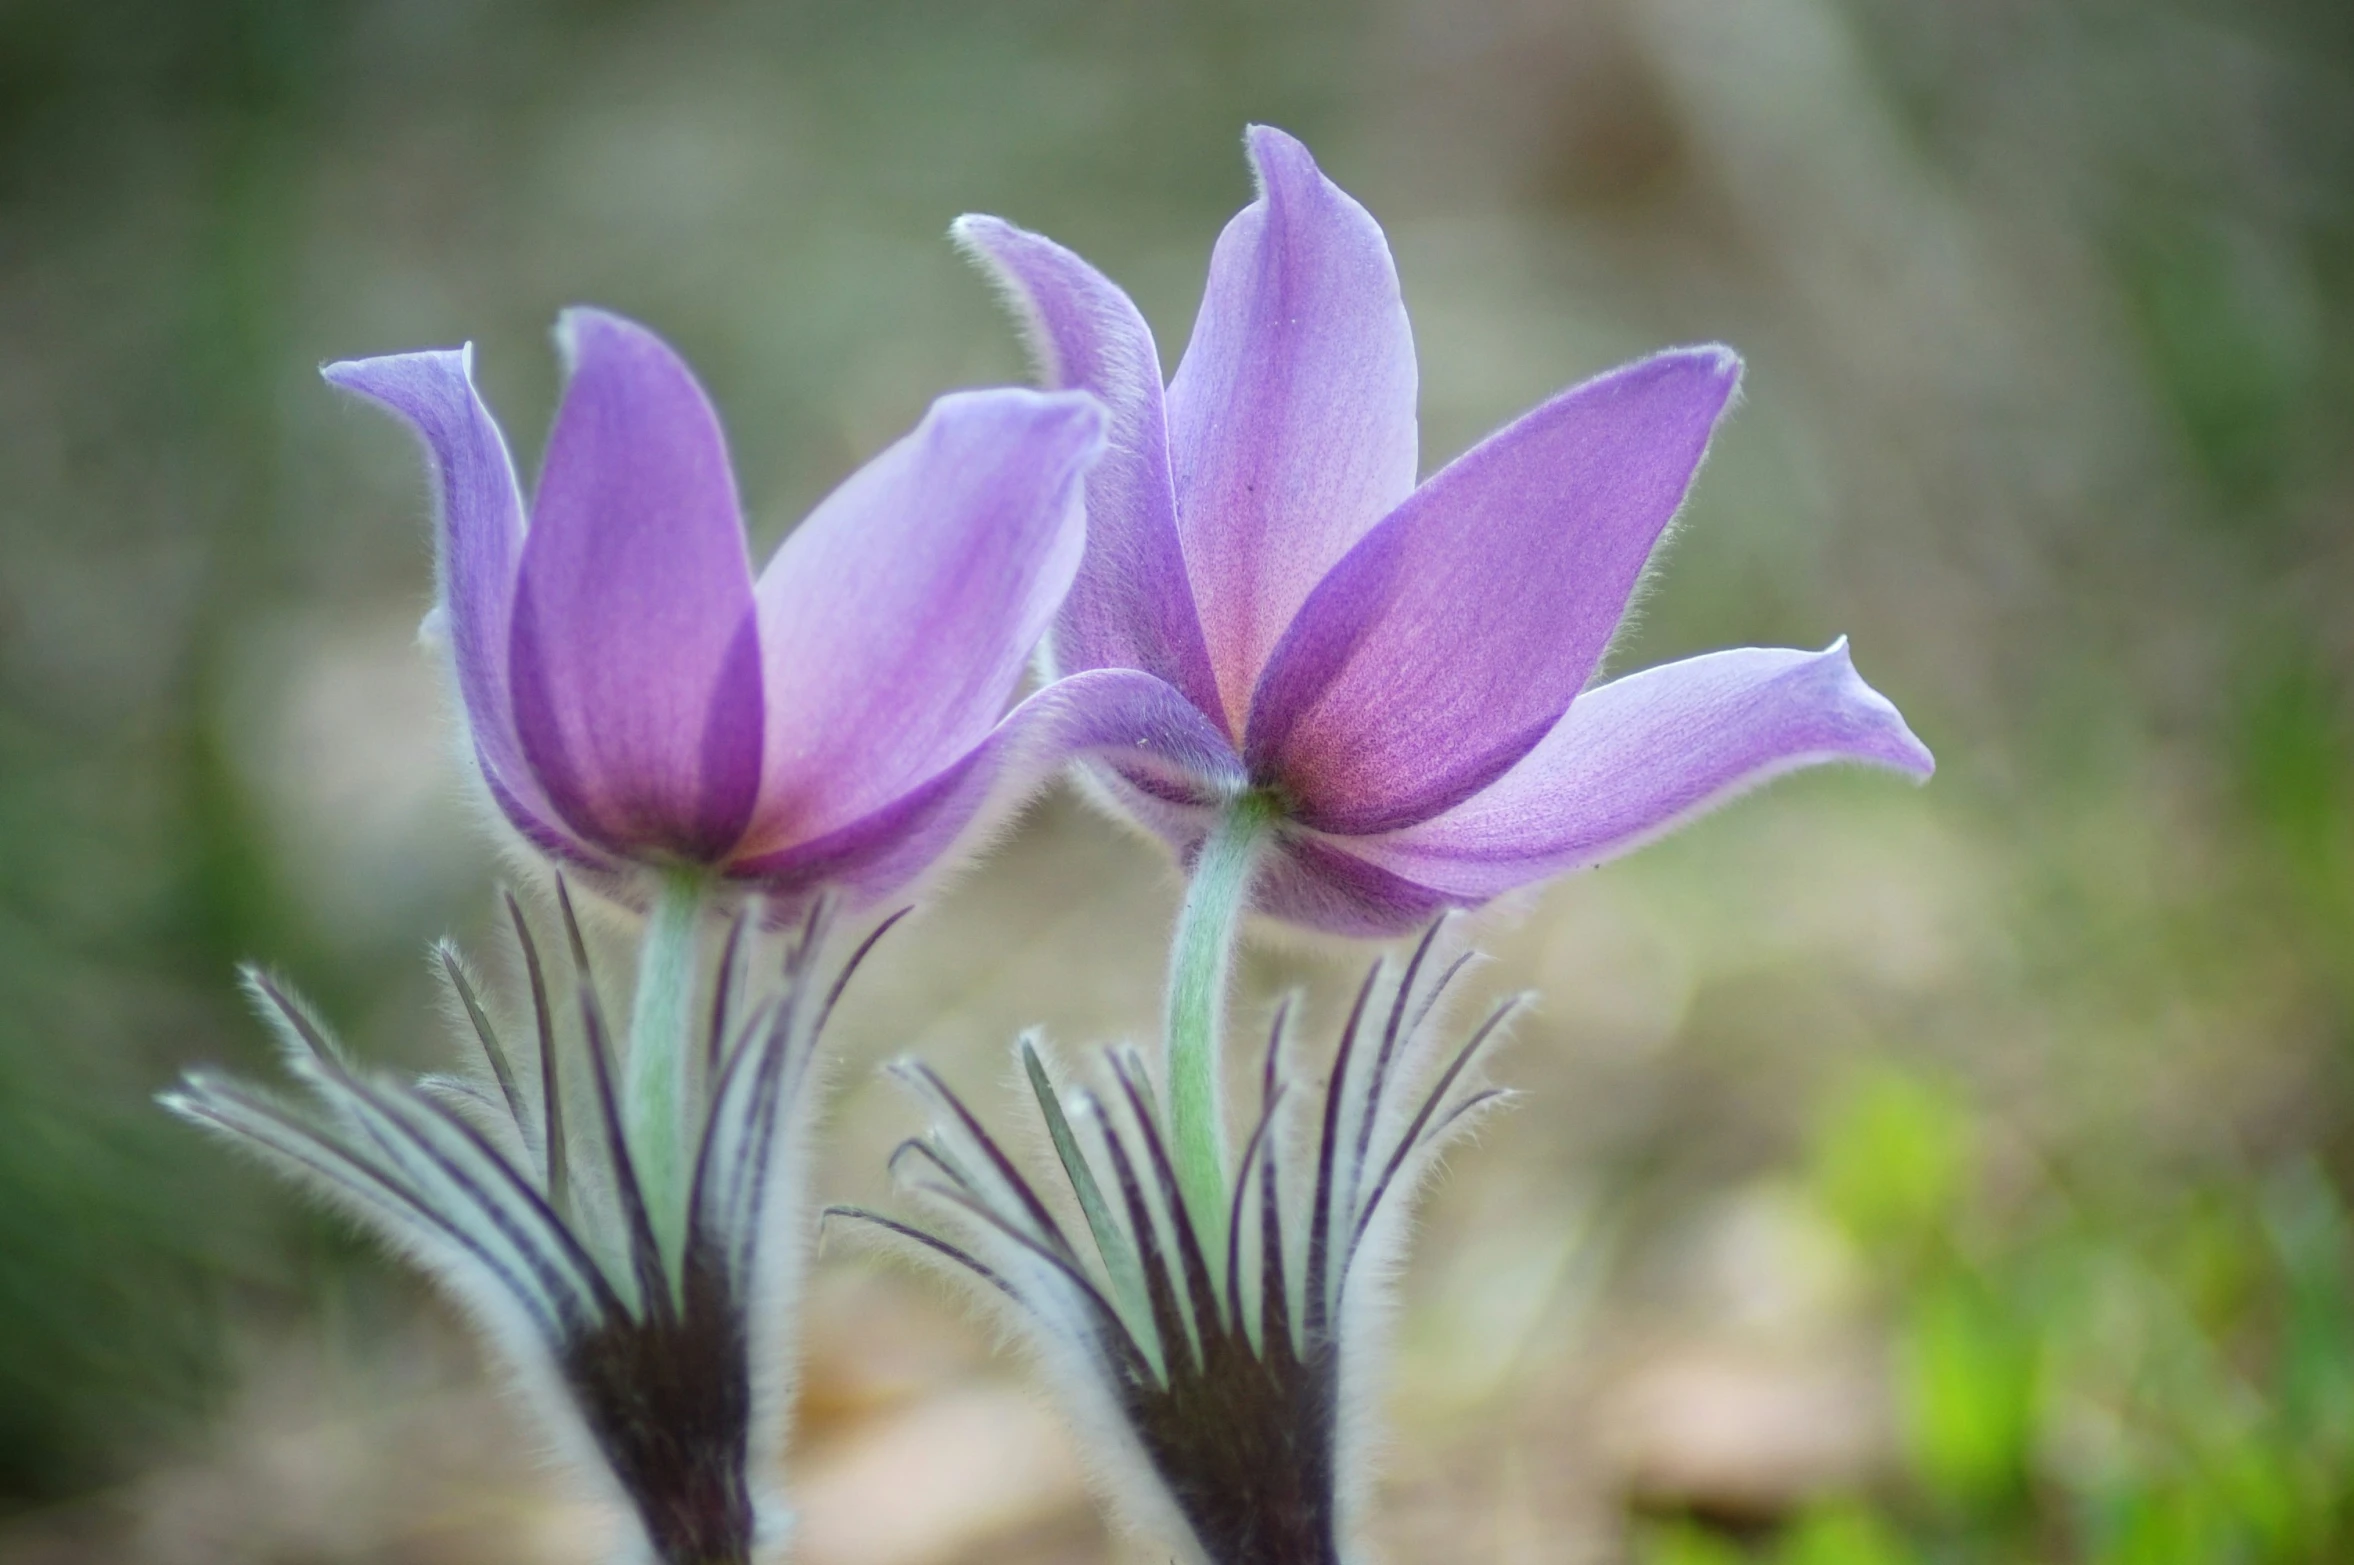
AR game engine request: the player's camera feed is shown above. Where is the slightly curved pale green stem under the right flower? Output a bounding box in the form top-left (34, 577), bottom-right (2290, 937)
top-left (1165, 793), bottom-right (1274, 1254)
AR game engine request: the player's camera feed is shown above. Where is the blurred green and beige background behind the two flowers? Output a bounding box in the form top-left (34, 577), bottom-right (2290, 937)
top-left (0, 0), bottom-right (2354, 1565)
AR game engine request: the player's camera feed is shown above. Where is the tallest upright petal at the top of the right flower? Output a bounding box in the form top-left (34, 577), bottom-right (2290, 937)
top-left (1168, 125), bottom-right (1415, 732)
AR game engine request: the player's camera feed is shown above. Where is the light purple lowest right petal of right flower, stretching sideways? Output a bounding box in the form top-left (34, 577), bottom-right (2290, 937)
top-left (1349, 640), bottom-right (1935, 901)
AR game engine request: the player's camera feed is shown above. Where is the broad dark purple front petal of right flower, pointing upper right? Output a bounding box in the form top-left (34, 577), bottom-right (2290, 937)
top-left (1243, 348), bottom-right (1740, 835)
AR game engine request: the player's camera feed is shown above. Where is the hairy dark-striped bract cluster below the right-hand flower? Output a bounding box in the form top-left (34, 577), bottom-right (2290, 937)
top-left (829, 925), bottom-right (1518, 1565)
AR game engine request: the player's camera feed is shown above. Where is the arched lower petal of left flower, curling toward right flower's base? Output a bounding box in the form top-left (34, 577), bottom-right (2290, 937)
top-left (727, 668), bottom-right (1243, 901)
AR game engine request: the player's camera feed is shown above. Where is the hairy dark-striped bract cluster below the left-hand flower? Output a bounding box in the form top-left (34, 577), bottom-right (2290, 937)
top-left (165, 885), bottom-right (880, 1565)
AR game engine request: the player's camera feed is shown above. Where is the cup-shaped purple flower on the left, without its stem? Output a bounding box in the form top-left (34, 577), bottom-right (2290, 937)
top-left (325, 308), bottom-right (1219, 899)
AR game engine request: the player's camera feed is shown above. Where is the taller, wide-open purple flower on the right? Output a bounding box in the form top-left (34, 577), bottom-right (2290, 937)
top-left (958, 127), bottom-right (1933, 934)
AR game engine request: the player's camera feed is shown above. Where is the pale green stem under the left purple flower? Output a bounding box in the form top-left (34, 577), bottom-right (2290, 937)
top-left (621, 871), bottom-right (709, 1268)
